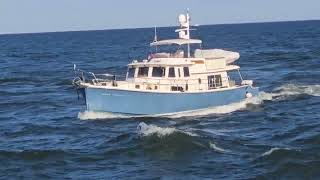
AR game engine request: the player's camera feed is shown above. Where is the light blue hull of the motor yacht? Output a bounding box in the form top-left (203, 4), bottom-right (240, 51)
top-left (86, 86), bottom-right (258, 114)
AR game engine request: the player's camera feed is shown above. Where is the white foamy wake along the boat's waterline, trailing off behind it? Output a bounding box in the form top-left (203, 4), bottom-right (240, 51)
top-left (78, 84), bottom-right (320, 120)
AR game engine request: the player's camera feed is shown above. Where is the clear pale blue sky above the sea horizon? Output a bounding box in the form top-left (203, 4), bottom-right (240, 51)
top-left (0, 0), bottom-right (320, 34)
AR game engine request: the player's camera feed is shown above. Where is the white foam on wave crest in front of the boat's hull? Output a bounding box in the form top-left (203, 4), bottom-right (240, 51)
top-left (137, 122), bottom-right (197, 137)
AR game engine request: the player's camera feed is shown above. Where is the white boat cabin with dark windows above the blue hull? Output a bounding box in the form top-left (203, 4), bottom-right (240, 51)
top-left (122, 39), bottom-right (239, 92)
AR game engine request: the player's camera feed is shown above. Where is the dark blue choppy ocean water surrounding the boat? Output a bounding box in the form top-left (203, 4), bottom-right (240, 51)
top-left (0, 21), bottom-right (320, 179)
